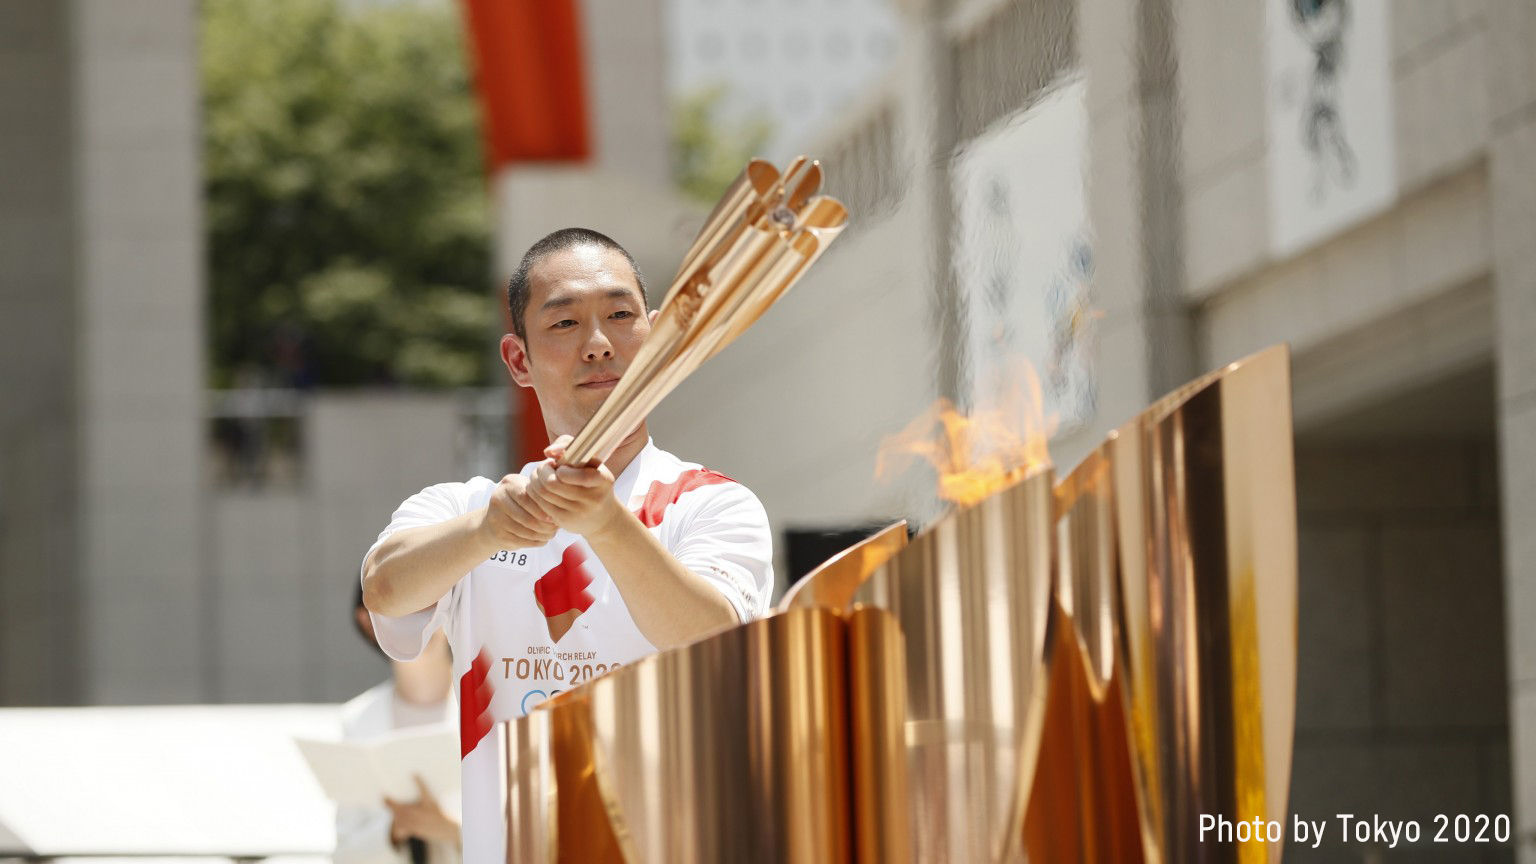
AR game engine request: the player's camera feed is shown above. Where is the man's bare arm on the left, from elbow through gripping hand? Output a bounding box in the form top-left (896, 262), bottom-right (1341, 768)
top-left (362, 474), bottom-right (556, 618)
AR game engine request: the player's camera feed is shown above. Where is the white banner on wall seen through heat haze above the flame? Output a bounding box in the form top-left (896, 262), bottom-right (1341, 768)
top-left (954, 78), bottom-right (1095, 435)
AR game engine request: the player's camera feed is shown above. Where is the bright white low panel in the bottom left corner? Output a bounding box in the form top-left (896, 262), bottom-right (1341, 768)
top-left (0, 706), bottom-right (341, 859)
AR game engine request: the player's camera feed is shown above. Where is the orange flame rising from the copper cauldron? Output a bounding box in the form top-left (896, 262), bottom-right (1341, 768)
top-left (876, 361), bottom-right (1054, 506)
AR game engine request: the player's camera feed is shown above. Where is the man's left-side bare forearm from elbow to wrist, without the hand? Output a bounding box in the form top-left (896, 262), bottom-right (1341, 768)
top-left (362, 507), bottom-right (496, 618)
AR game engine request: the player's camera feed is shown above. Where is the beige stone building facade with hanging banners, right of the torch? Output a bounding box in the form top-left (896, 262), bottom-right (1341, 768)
top-left (656, 0), bottom-right (1536, 861)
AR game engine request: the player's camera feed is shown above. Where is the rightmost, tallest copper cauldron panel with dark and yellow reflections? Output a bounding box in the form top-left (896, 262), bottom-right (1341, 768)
top-left (1026, 347), bottom-right (1296, 862)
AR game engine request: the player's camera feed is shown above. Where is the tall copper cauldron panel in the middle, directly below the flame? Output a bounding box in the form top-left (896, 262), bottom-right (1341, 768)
top-left (856, 469), bottom-right (1052, 861)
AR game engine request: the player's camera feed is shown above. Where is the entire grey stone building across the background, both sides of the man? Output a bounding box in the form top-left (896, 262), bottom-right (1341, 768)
top-left (0, 0), bottom-right (1536, 861)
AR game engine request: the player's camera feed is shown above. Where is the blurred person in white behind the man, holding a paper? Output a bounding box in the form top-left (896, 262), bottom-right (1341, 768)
top-left (345, 586), bottom-right (462, 864)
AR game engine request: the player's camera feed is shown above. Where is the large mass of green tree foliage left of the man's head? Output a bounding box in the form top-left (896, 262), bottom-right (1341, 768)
top-left (203, 0), bottom-right (498, 387)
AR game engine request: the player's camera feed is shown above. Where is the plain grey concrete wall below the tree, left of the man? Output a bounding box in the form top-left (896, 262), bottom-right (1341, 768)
top-left (207, 394), bottom-right (467, 703)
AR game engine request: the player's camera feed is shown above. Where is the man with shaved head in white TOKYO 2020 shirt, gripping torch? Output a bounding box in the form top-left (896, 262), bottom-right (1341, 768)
top-left (362, 228), bottom-right (773, 864)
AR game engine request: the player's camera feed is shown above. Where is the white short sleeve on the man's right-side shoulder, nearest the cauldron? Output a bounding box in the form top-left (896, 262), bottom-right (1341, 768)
top-left (671, 483), bottom-right (773, 621)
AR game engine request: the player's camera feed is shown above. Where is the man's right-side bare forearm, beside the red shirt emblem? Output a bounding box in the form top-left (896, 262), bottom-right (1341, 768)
top-left (585, 510), bottom-right (739, 649)
